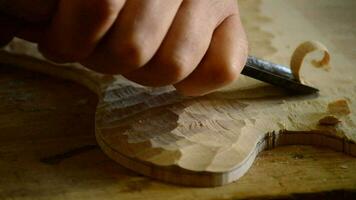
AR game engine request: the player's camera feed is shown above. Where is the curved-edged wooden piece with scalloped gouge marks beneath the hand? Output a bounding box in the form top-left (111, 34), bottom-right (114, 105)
top-left (0, 41), bottom-right (356, 186)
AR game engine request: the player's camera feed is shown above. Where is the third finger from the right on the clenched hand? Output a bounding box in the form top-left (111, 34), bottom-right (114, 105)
top-left (84, 0), bottom-right (182, 73)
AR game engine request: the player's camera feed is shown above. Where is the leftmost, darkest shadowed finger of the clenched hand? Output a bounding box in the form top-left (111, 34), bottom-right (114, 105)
top-left (39, 0), bottom-right (125, 62)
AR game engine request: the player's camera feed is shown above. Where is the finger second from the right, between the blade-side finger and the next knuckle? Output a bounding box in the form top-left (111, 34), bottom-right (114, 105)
top-left (125, 0), bottom-right (237, 86)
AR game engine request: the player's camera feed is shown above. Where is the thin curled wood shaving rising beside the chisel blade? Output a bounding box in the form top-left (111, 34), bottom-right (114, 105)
top-left (290, 41), bottom-right (330, 81)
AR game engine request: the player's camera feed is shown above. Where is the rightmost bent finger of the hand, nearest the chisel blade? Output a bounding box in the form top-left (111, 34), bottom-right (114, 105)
top-left (175, 15), bottom-right (248, 96)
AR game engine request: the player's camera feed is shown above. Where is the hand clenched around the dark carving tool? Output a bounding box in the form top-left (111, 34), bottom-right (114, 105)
top-left (0, 0), bottom-right (247, 96)
